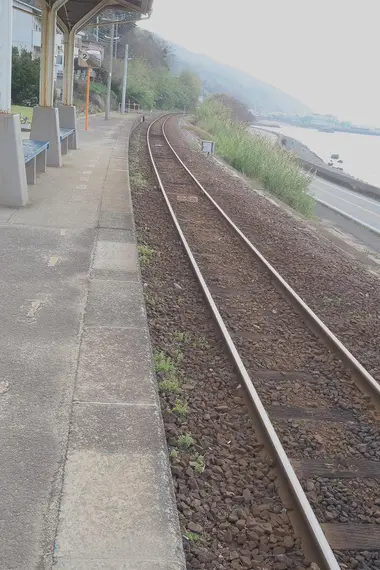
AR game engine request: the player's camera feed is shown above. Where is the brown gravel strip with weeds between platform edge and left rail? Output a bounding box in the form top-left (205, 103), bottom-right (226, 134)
top-left (131, 120), bottom-right (316, 570)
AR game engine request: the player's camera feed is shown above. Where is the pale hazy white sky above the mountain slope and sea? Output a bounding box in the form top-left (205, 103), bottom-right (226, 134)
top-left (144, 0), bottom-right (380, 126)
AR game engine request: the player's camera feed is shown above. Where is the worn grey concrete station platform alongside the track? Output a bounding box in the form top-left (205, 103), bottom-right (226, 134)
top-left (0, 113), bottom-right (185, 570)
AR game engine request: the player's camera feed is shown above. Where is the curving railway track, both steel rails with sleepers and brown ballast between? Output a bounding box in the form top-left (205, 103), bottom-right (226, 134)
top-left (147, 116), bottom-right (380, 569)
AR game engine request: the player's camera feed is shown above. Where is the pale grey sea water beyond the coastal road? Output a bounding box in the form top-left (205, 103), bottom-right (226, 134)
top-left (262, 125), bottom-right (380, 187)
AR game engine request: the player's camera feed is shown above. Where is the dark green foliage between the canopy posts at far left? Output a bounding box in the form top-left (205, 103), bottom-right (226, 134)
top-left (12, 47), bottom-right (40, 107)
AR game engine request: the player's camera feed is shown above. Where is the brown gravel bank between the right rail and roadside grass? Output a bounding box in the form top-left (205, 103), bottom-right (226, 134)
top-left (167, 115), bottom-right (380, 380)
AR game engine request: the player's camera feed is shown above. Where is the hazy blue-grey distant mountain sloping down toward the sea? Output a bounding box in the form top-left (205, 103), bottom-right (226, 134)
top-left (171, 44), bottom-right (312, 115)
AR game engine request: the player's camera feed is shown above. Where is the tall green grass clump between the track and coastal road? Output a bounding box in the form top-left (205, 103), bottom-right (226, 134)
top-left (197, 101), bottom-right (315, 216)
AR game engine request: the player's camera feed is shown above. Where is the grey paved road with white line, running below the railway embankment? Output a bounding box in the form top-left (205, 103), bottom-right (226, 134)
top-left (310, 178), bottom-right (380, 233)
